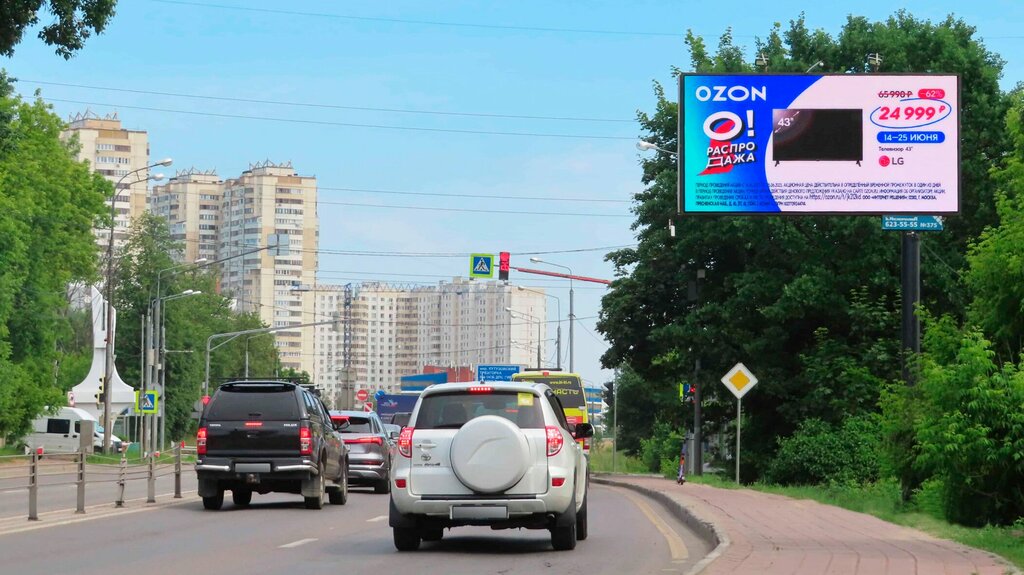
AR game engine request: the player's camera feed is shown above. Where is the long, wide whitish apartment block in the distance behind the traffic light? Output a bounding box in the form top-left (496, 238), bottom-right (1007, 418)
top-left (312, 278), bottom-right (554, 405)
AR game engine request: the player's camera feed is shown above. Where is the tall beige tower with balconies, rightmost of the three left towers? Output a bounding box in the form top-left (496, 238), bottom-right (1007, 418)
top-left (217, 161), bottom-right (321, 374)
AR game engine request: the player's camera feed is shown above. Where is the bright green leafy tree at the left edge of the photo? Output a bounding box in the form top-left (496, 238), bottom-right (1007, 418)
top-left (0, 76), bottom-right (112, 437)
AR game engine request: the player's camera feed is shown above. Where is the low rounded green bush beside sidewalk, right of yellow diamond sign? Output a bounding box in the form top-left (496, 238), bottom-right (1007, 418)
top-left (765, 415), bottom-right (881, 485)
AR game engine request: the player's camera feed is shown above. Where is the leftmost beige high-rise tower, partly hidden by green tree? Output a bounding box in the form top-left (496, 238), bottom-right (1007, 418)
top-left (62, 112), bottom-right (150, 249)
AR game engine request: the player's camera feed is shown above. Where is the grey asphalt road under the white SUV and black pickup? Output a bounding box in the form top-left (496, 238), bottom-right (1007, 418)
top-left (0, 484), bottom-right (710, 575)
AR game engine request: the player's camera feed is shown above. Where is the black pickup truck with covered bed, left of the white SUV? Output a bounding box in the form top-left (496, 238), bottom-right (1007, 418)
top-left (196, 381), bottom-right (348, 510)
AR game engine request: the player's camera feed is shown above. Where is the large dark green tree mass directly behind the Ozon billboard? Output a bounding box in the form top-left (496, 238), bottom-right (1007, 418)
top-left (598, 11), bottom-right (1007, 477)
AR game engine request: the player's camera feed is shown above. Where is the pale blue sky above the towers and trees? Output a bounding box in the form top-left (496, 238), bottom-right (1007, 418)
top-left (0, 0), bottom-right (1024, 383)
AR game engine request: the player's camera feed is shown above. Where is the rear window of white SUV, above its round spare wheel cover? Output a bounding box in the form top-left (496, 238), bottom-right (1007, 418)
top-left (416, 391), bottom-right (544, 430)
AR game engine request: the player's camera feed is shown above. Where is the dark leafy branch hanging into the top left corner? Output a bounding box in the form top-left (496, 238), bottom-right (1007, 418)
top-left (0, 0), bottom-right (117, 59)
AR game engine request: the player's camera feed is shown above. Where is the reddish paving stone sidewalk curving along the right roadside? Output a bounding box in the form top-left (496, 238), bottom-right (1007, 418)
top-left (604, 475), bottom-right (1020, 575)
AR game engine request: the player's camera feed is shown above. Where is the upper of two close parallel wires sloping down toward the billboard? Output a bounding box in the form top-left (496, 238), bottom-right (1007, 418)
top-left (22, 78), bottom-right (636, 124)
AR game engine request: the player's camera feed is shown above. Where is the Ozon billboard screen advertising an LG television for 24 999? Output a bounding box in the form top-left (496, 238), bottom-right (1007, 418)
top-left (679, 74), bottom-right (959, 215)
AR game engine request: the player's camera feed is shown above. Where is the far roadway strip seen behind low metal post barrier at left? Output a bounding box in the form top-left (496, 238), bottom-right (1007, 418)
top-left (0, 463), bottom-right (197, 521)
